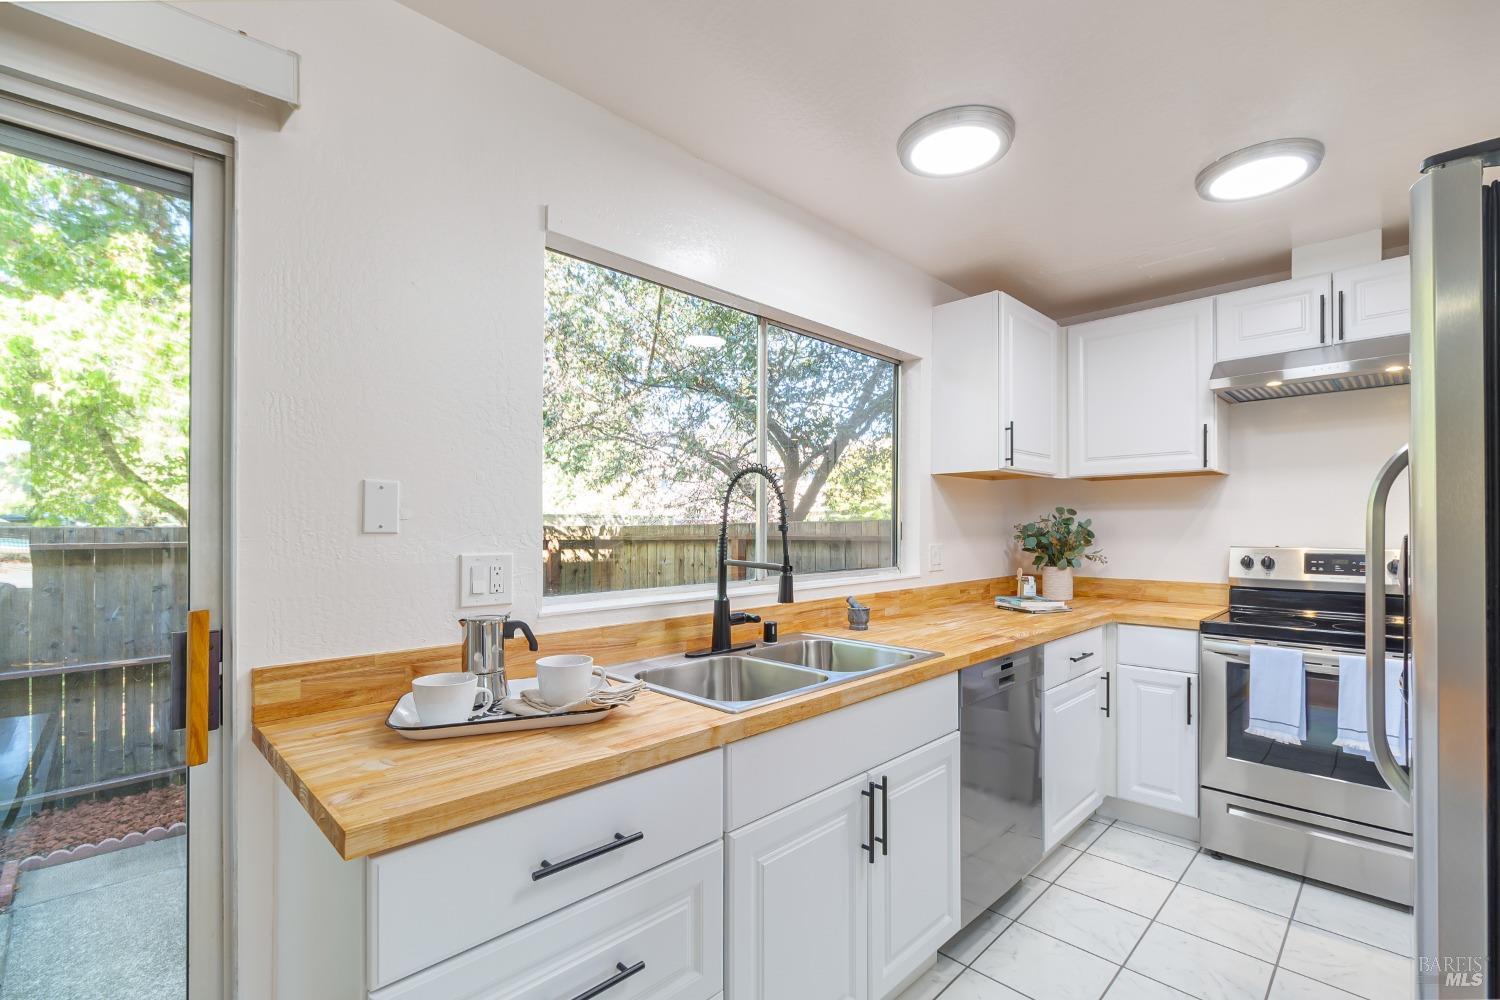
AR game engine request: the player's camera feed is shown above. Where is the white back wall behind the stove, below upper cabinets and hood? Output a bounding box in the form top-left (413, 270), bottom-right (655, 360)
top-left (1004, 385), bottom-right (1409, 583)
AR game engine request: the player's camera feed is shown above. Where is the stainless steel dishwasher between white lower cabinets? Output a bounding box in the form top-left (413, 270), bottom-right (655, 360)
top-left (959, 648), bottom-right (1043, 925)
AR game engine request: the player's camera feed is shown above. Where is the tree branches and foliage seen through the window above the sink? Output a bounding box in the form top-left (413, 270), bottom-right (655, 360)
top-left (543, 253), bottom-right (896, 520)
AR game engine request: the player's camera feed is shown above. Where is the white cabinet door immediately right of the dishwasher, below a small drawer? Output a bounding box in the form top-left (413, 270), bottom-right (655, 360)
top-left (1041, 669), bottom-right (1104, 852)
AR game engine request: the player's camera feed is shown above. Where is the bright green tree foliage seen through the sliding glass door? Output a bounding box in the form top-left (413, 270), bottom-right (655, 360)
top-left (0, 151), bottom-right (191, 525)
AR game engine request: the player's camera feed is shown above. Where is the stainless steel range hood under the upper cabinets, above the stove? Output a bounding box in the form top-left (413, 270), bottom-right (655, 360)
top-left (1209, 333), bottom-right (1412, 403)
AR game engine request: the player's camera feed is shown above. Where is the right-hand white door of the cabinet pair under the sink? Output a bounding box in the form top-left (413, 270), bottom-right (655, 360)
top-left (861, 733), bottom-right (960, 997)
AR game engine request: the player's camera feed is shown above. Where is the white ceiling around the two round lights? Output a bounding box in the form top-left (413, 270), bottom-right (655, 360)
top-left (405, 0), bottom-right (1500, 316)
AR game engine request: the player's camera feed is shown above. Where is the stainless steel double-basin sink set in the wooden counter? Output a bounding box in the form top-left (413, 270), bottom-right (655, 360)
top-left (609, 633), bottom-right (942, 712)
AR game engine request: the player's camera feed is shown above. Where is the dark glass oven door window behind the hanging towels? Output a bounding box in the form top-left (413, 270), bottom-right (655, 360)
top-left (1224, 660), bottom-right (1410, 789)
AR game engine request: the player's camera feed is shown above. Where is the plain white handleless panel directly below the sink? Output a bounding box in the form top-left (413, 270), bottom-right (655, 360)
top-left (725, 673), bottom-right (959, 829)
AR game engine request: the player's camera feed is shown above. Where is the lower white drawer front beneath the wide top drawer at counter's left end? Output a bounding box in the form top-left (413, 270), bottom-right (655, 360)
top-left (371, 843), bottom-right (725, 1000)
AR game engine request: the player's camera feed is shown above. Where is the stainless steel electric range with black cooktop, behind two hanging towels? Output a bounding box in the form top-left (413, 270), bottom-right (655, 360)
top-left (1199, 547), bottom-right (1413, 906)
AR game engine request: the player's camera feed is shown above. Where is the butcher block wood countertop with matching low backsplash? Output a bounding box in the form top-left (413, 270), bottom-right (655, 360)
top-left (251, 577), bottom-right (1227, 859)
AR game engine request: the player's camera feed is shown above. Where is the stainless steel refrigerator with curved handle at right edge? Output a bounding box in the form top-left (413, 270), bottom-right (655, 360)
top-left (1365, 139), bottom-right (1500, 997)
